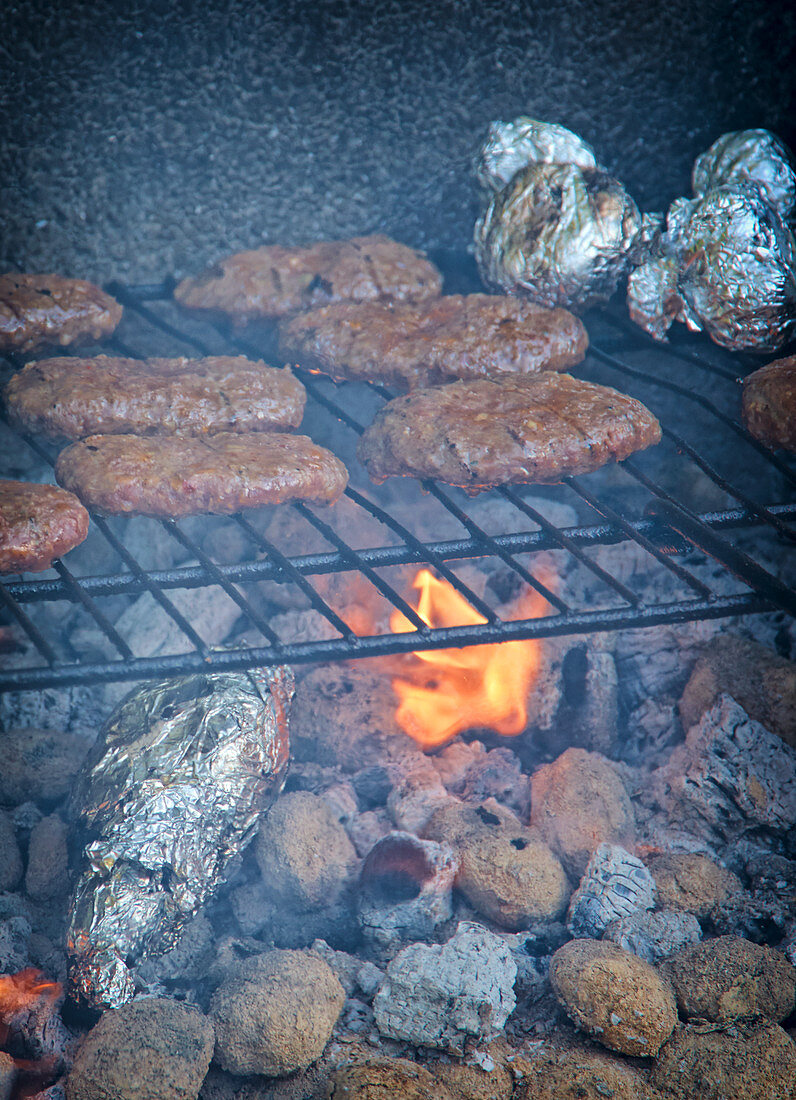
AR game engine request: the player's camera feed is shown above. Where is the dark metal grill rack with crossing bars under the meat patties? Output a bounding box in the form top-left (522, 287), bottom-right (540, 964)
top-left (0, 264), bottom-right (796, 691)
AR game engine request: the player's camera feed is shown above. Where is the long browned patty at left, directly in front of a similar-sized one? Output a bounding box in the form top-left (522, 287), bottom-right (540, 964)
top-left (55, 431), bottom-right (347, 516)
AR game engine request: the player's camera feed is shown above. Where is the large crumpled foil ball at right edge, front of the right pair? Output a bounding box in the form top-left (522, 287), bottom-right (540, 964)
top-left (628, 182), bottom-right (796, 352)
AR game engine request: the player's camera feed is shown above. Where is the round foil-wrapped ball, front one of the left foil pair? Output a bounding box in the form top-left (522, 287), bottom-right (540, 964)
top-left (475, 164), bottom-right (641, 310)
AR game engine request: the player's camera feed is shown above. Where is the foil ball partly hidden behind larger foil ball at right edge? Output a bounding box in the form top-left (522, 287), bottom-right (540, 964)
top-left (692, 130), bottom-right (796, 221)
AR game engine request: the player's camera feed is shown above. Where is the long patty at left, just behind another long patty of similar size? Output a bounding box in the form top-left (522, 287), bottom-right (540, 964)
top-left (5, 355), bottom-right (307, 439)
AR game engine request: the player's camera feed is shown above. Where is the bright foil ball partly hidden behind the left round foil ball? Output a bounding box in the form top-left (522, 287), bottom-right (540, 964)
top-left (475, 114), bottom-right (598, 193)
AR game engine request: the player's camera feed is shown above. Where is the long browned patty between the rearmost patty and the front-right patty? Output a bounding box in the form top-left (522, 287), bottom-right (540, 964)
top-left (279, 294), bottom-right (588, 389)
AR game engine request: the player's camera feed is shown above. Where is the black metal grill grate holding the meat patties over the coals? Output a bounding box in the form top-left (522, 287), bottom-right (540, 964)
top-left (0, 272), bottom-right (796, 690)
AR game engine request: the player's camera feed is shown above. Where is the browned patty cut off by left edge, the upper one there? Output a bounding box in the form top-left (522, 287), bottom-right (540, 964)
top-left (0, 275), bottom-right (122, 353)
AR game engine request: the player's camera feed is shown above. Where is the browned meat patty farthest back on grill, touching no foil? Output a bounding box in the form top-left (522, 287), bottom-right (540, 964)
top-left (174, 234), bottom-right (442, 325)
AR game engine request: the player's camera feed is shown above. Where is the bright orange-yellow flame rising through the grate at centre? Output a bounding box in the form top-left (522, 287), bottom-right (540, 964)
top-left (390, 569), bottom-right (548, 748)
